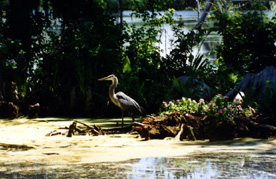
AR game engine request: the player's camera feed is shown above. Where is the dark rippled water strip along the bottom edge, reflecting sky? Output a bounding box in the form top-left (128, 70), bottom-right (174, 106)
top-left (0, 152), bottom-right (276, 179)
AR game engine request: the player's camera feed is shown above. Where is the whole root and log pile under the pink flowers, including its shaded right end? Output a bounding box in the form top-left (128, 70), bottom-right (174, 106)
top-left (132, 112), bottom-right (276, 141)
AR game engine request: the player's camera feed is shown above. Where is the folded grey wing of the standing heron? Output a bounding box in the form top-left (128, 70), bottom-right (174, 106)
top-left (116, 92), bottom-right (144, 115)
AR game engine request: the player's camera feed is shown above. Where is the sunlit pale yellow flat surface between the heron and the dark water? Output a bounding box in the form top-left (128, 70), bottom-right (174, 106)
top-left (0, 118), bottom-right (276, 164)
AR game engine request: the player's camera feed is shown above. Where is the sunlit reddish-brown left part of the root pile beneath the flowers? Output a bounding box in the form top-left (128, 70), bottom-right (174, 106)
top-left (132, 112), bottom-right (204, 140)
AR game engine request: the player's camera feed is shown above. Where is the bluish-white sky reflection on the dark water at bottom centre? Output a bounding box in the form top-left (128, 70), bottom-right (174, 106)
top-left (127, 158), bottom-right (220, 179)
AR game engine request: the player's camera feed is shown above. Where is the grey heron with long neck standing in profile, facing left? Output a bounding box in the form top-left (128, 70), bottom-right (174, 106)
top-left (99, 74), bottom-right (144, 128)
